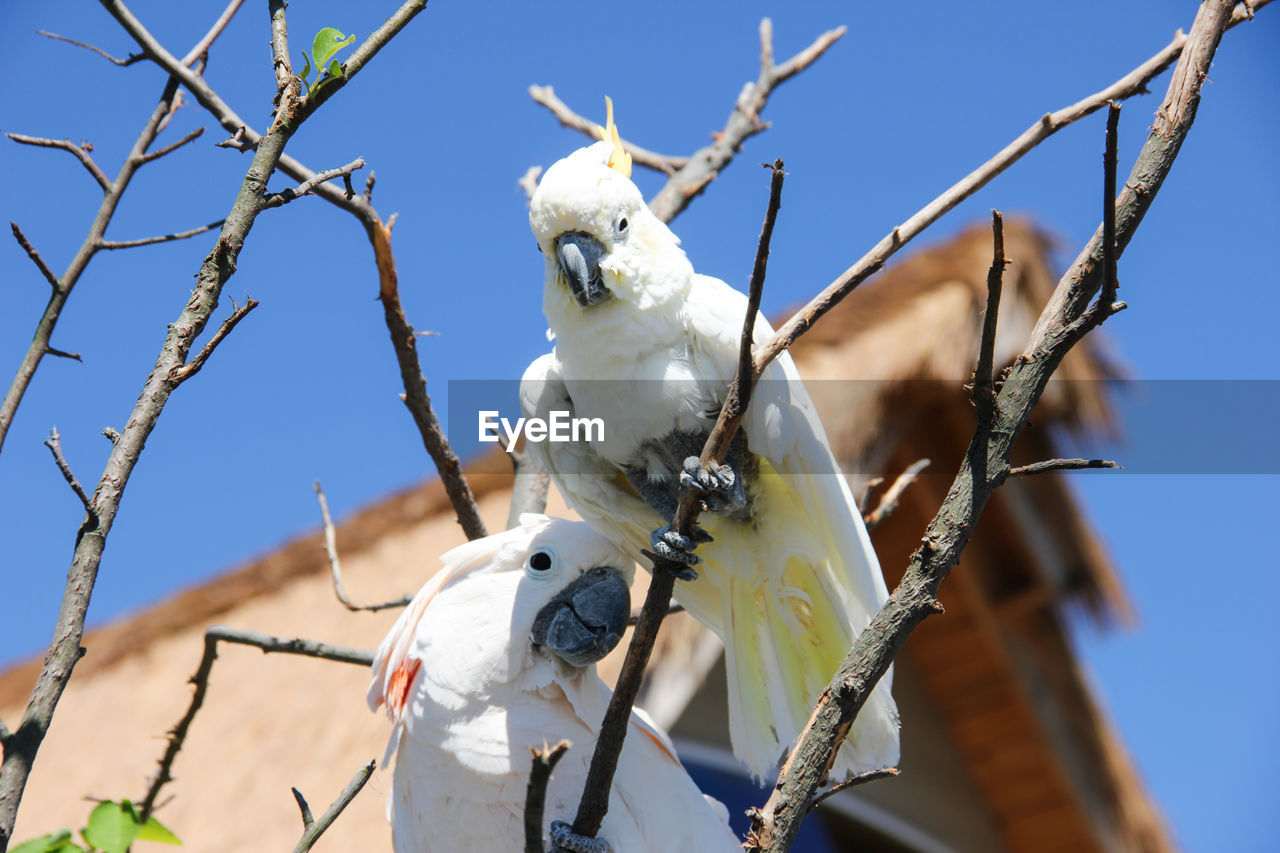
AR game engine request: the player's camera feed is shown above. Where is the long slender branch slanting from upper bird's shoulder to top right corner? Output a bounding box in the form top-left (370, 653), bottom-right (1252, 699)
top-left (755, 0), bottom-right (1270, 368)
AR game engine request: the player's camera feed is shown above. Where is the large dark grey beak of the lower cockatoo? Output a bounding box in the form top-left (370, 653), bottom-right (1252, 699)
top-left (529, 566), bottom-right (631, 666)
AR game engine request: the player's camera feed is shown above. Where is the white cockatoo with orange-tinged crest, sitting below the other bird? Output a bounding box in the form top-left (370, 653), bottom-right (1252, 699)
top-left (369, 514), bottom-right (740, 853)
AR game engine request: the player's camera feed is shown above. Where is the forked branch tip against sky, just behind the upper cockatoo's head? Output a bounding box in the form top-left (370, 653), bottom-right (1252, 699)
top-left (649, 18), bottom-right (846, 223)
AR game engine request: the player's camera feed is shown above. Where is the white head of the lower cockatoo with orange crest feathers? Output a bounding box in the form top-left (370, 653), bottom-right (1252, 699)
top-left (369, 514), bottom-right (634, 719)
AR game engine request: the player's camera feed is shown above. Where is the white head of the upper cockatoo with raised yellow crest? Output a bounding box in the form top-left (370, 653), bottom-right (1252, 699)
top-left (529, 99), bottom-right (692, 325)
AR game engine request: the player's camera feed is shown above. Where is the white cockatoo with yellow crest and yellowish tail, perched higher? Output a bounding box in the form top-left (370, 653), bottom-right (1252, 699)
top-left (520, 104), bottom-right (899, 777)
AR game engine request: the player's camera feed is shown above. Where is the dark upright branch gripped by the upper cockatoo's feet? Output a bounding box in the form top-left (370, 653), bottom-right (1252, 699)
top-left (573, 159), bottom-right (786, 838)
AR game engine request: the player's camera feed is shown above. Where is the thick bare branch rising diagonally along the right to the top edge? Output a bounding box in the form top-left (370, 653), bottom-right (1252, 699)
top-left (748, 0), bottom-right (1235, 853)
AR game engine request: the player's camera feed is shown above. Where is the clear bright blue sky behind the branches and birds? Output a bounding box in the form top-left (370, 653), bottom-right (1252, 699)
top-left (0, 0), bottom-right (1280, 850)
